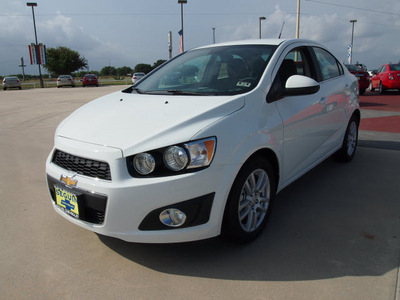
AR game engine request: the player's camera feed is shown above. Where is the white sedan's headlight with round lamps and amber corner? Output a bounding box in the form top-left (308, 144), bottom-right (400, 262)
top-left (127, 137), bottom-right (217, 177)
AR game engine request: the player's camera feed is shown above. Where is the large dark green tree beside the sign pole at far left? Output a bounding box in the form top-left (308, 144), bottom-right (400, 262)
top-left (44, 46), bottom-right (87, 76)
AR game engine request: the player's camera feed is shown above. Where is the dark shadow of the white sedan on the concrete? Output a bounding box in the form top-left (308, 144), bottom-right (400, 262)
top-left (99, 147), bottom-right (400, 281)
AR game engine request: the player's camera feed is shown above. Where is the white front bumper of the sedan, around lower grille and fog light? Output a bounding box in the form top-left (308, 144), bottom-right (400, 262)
top-left (46, 137), bottom-right (239, 243)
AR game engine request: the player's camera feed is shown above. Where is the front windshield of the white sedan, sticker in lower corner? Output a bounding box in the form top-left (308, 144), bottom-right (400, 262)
top-left (125, 45), bottom-right (276, 95)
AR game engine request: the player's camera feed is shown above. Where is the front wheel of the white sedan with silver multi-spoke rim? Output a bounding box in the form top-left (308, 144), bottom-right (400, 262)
top-left (222, 157), bottom-right (276, 243)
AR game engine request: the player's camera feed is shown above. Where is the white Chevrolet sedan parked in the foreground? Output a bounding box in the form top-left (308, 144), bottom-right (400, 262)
top-left (46, 39), bottom-right (360, 243)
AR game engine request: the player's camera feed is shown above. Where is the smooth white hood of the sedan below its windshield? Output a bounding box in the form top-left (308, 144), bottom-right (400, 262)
top-left (56, 92), bottom-right (244, 156)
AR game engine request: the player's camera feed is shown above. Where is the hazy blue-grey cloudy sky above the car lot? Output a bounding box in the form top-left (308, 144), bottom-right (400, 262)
top-left (0, 0), bottom-right (400, 75)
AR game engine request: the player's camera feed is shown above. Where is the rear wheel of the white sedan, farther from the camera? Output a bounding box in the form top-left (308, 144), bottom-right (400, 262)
top-left (332, 115), bottom-right (360, 162)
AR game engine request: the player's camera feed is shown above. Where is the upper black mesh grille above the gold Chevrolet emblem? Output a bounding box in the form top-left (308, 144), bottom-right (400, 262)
top-left (52, 150), bottom-right (111, 180)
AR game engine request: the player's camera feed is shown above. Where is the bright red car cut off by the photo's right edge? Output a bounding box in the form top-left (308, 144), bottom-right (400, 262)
top-left (370, 64), bottom-right (400, 94)
